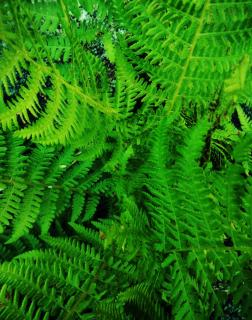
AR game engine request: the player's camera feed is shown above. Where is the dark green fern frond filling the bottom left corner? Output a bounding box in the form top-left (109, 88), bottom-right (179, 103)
top-left (0, 237), bottom-right (142, 319)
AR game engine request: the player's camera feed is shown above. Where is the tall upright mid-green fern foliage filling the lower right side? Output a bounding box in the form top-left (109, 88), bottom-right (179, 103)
top-left (143, 121), bottom-right (251, 319)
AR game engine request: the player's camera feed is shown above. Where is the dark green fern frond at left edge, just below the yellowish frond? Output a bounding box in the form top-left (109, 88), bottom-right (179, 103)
top-left (0, 129), bottom-right (116, 242)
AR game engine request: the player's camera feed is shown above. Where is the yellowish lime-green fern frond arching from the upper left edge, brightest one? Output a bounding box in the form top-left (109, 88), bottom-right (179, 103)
top-left (0, 5), bottom-right (115, 144)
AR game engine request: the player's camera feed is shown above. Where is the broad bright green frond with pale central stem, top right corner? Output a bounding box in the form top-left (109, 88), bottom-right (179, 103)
top-left (116, 0), bottom-right (251, 112)
